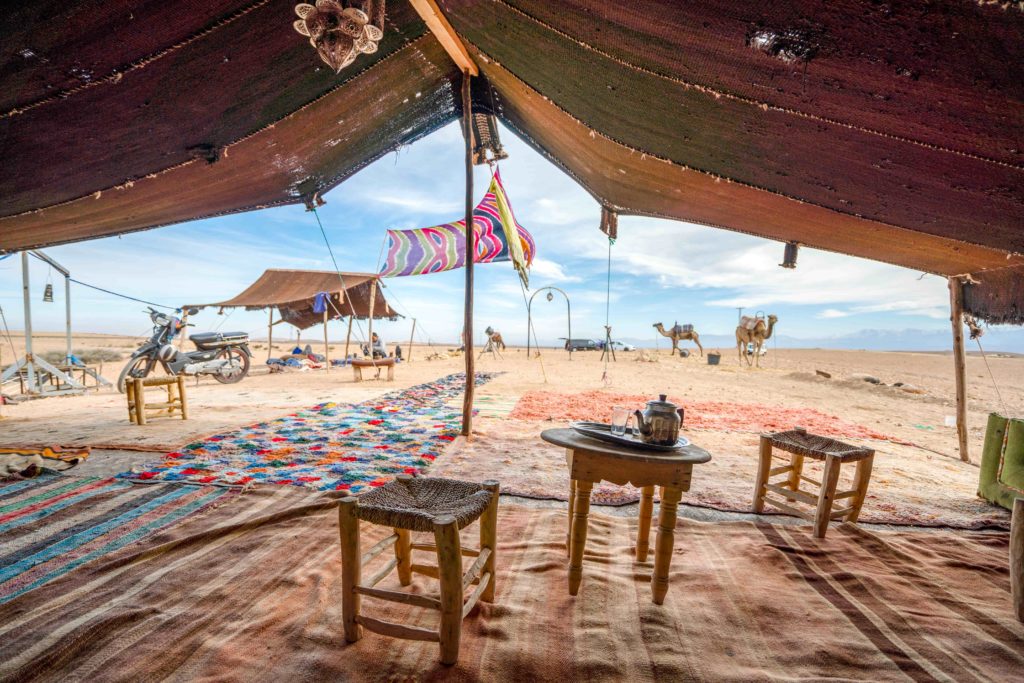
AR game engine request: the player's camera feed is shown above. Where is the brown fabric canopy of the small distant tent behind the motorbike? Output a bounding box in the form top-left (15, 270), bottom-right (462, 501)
top-left (193, 268), bottom-right (402, 330)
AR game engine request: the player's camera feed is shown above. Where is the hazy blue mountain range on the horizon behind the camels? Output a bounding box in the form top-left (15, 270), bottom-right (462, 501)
top-left (546, 327), bottom-right (1024, 353)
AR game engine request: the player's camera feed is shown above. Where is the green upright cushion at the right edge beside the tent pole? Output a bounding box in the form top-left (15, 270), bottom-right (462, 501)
top-left (978, 413), bottom-right (1024, 510)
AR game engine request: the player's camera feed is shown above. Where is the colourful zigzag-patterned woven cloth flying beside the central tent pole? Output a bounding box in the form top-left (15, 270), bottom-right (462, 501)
top-left (380, 172), bottom-right (537, 285)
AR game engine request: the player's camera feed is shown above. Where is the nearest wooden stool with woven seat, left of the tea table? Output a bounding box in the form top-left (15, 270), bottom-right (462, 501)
top-left (338, 474), bottom-right (498, 665)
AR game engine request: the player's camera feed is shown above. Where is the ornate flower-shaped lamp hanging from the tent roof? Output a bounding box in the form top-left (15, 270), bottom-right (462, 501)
top-left (292, 0), bottom-right (384, 73)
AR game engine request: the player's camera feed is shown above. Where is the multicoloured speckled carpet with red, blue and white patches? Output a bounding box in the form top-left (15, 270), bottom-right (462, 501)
top-left (119, 373), bottom-right (497, 494)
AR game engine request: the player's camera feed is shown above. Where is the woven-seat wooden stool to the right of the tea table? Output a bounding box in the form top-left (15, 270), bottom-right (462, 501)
top-left (754, 427), bottom-right (874, 539)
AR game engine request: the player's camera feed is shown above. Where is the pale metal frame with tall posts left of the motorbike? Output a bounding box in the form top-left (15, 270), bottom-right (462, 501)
top-left (0, 250), bottom-right (111, 396)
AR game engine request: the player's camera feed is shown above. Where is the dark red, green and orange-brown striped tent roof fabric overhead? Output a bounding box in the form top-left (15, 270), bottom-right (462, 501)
top-left (0, 0), bottom-right (1024, 323)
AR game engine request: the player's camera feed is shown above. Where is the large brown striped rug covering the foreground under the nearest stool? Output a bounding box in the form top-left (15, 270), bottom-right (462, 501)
top-left (0, 487), bottom-right (1024, 683)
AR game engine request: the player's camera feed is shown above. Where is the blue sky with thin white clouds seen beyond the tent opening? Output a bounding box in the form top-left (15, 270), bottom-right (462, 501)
top-left (0, 119), bottom-right (1024, 348)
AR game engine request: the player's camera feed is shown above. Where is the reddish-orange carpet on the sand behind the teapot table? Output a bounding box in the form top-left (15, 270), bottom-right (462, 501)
top-left (512, 391), bottom-right (905, 443)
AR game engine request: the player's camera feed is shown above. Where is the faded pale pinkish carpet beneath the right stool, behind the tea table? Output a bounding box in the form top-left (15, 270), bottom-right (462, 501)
top-left (430, 418), bottom-right (1010, 528)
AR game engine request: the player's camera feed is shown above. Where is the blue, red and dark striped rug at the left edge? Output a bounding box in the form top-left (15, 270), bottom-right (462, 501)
top-left (0, 474), bottom-right (238, 603)
